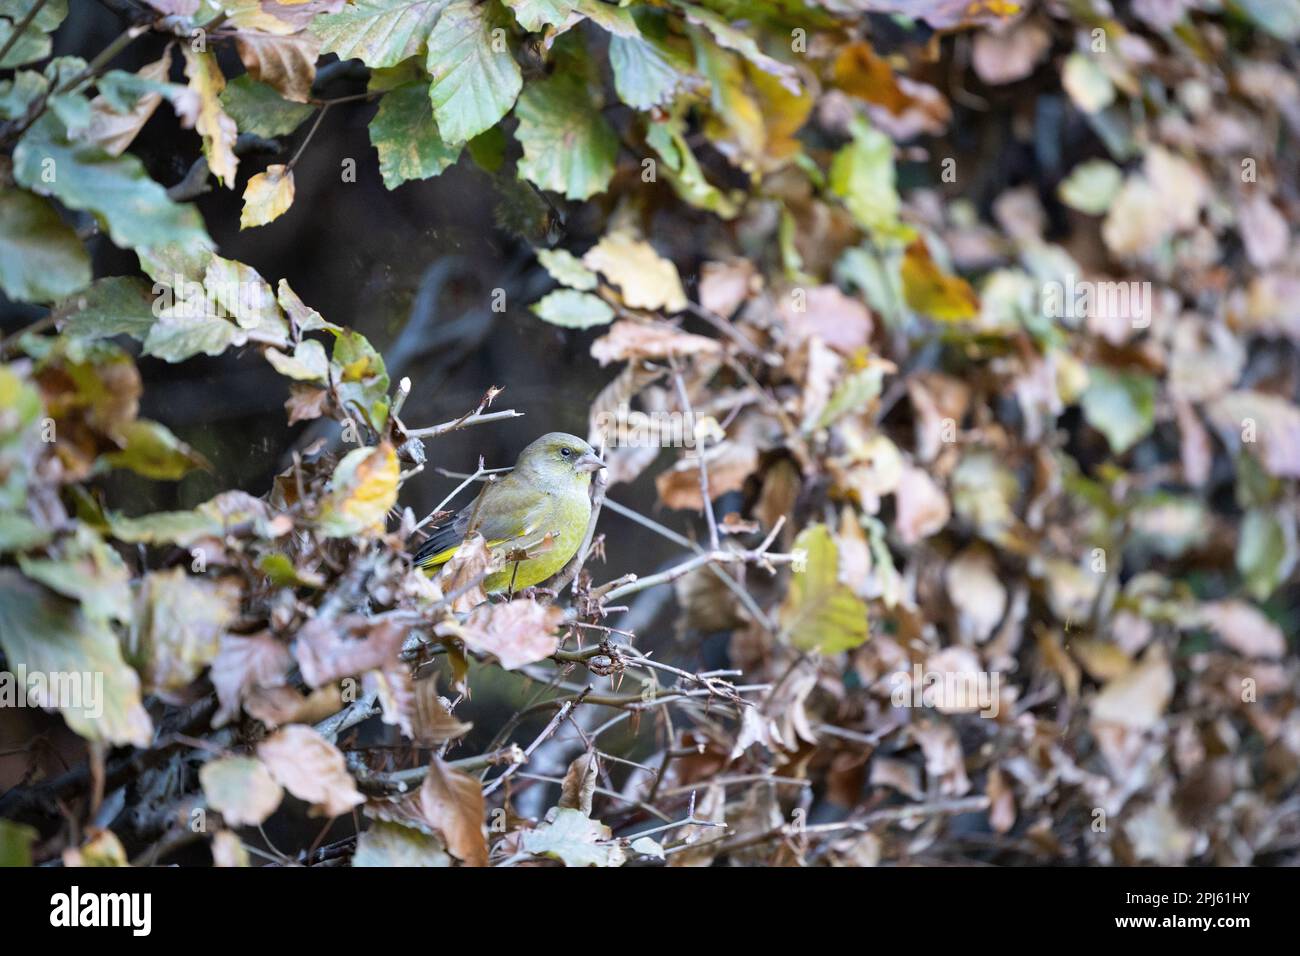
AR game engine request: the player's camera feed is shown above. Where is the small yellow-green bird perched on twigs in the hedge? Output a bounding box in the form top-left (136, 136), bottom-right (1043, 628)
top-left (415, 432), bottom-right (605, 592)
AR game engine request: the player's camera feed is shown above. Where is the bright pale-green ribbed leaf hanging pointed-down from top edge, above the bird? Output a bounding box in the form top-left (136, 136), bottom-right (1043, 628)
top-left (428, 0), bottom-right (524, 143)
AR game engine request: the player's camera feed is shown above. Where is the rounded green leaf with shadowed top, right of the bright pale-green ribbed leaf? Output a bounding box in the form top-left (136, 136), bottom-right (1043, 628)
top-left (515, 73), bottom-right (619, 199)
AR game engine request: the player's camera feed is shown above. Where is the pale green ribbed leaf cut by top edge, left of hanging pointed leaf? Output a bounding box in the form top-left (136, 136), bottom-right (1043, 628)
top-left (311, 0), bottom-right (449, 66)
